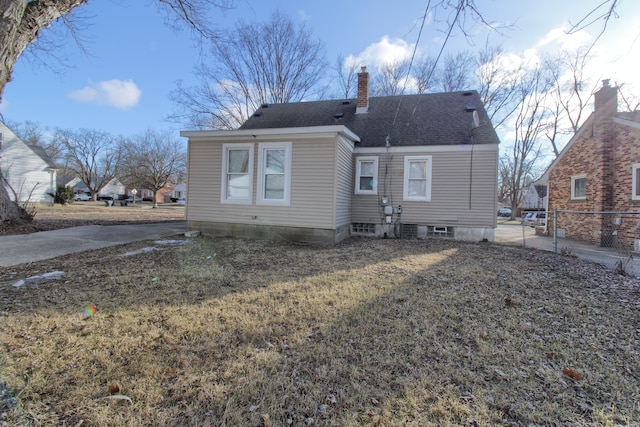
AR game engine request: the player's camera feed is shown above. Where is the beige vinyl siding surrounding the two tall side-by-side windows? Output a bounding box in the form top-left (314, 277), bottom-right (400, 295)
top-left (187, 137), bottom-right (336, 229)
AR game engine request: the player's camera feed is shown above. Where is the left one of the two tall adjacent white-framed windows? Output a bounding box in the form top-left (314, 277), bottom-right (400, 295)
top-left (221, 144), bottom-right (253, 204)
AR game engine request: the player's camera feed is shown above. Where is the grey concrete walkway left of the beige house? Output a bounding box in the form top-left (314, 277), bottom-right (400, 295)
top-left (0, 221), bottom-right (187, 267)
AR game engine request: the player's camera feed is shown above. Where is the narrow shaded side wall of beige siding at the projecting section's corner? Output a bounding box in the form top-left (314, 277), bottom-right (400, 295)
top-left (335, 140), bottom-right (354, 227)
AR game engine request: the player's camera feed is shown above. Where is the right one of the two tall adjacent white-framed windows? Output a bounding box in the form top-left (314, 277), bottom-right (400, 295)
top-left (258, 142), bottom-right (291, 205)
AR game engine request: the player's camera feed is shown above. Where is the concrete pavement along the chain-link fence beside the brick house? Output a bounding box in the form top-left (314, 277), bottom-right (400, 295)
top-left (495, 223), bottom-right (640, 277)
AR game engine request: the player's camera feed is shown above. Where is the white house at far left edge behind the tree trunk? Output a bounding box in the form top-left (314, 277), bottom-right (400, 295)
top-left (0, 121), bottom-right (56, 203)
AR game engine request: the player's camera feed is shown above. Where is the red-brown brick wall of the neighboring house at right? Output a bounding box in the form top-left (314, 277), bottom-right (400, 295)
top-left (549, 114), bottom-right (640, 247)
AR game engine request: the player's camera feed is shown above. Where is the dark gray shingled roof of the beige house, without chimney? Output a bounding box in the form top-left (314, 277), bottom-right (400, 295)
top-left (240, 91), bottom-right (499, 147)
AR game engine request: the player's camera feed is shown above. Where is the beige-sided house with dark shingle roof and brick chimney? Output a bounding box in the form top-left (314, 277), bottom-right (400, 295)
top-left (181, 67), bottom-right (499, 244)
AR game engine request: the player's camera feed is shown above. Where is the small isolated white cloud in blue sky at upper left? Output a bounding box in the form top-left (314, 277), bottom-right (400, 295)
top-left (69, 79), bottom-right (142, 110)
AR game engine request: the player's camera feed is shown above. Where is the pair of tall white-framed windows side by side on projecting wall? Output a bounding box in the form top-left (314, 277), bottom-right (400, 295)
top-left (221, 142), bottom-right (291, 205)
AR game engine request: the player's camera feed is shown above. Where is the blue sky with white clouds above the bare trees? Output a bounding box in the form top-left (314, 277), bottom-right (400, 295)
top-left (0, 0), bottom-right (640, 141)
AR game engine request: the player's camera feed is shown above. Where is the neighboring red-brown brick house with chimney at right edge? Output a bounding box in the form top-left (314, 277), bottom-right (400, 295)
top-left (536, 80), bottom-right (640, 248)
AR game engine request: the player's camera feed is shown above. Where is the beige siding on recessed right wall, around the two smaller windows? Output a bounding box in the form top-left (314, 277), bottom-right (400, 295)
top-left (351, 145), bottom-right (498, 228)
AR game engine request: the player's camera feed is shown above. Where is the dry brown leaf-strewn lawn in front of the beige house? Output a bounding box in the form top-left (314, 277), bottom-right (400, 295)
top-left (0, 208), bottom-right (640, 426)
